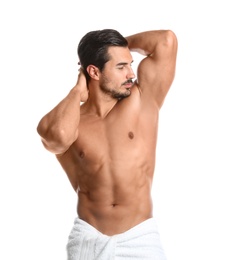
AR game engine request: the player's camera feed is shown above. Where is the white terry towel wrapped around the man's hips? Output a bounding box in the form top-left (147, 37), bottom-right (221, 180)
top-left (67, 218), bottom-right (166, 260)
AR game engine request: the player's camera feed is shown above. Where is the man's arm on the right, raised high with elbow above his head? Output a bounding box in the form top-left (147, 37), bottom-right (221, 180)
top-left (126, 30), bottom-right (177, 108)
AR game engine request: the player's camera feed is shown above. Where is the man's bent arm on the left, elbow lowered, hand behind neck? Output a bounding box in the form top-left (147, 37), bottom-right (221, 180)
top-left (37, 72), bottom-right (88, 154)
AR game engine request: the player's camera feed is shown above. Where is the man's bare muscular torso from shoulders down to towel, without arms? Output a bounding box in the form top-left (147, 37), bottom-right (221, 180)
top-left (57, 86), bottom-right (158, 235)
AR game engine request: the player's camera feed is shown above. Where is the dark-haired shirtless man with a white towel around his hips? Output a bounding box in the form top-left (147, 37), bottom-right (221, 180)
top-left (37, 29), bottom-right (177, 260)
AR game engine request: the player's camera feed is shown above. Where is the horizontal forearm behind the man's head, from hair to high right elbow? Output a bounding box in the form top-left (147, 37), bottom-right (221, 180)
top-left (126, 30), bottom-right (172, 56)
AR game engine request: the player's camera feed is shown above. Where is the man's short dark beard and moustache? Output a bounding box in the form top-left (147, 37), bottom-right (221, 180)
top-left (100, 77), bottom-right (132, 100)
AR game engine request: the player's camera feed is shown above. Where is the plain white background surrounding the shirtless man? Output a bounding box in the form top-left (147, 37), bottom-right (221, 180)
top-left (0, 0), bottom-right (230, 260)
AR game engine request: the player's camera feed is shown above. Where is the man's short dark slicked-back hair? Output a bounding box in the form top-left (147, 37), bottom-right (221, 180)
top-left (77, 29), bottom-right (128, 81)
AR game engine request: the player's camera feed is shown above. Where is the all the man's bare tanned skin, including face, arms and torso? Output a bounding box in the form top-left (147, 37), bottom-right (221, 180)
top-left (37, 30), bottom-right (177, 235)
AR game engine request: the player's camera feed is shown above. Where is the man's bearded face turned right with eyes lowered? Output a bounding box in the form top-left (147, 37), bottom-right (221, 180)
top-left (100, 47), bottom-right (135, 99)
